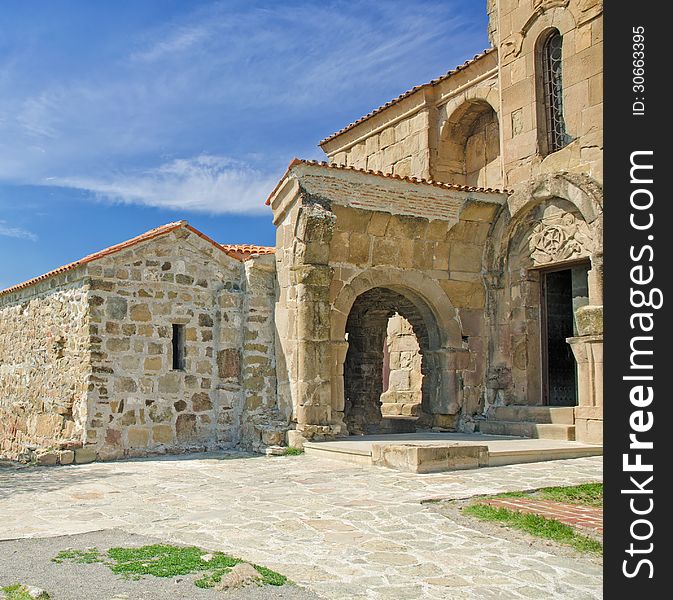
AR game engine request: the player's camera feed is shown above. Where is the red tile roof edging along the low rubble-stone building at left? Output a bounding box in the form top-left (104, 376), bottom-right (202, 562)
top-left (0, 221), bottom-right (275, 296)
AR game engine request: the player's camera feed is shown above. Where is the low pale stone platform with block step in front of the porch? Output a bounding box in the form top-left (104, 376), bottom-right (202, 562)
top-left (304, 432), bottom-right (603, 473)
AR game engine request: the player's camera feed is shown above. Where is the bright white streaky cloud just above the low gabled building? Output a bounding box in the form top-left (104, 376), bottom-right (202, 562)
top-left (45, 154), bottom-right (278, 214)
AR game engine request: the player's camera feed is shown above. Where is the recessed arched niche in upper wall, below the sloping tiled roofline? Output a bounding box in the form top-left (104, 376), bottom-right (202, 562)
top-left (433, 98), bottom-right (502, 187)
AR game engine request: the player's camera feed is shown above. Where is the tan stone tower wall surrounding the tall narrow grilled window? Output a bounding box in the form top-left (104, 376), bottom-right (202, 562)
top-left (495, 0), bottom-right (603, 187)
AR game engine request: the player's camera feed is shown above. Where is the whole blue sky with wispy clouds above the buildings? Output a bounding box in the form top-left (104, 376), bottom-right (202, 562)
top-left (0, 0), bottom-right (489, 289)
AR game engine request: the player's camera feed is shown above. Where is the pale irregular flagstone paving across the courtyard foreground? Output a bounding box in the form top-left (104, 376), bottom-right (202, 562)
top-left (0, 454), bottom-right (602, 600)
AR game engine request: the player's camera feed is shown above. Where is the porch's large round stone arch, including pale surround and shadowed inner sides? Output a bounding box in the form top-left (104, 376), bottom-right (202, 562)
top-left (331, 269), bottom-right (468, 433)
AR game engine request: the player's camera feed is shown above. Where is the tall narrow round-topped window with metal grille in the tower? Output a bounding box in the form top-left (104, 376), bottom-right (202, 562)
top-left (540, 29), bottom-right (571, 154)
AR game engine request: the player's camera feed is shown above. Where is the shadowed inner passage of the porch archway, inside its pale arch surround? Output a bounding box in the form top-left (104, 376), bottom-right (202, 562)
top-left (344, 287), bottom-right (441, 434)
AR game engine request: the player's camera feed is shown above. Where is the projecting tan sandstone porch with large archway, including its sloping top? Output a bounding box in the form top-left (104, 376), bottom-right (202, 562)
top-left (270, 163), bottom-right (505, 445)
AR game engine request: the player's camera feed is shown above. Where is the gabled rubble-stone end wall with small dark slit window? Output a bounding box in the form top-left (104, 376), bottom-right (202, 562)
top-left (86, 228), bottom-right (275, 459)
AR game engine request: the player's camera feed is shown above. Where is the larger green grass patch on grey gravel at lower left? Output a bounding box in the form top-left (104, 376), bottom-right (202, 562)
top-left (50, 544), bottom-right (287, 588)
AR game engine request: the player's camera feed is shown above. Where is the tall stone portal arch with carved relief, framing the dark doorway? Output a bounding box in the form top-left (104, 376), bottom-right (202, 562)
top-left (486, 173), bottom-right (603, 407)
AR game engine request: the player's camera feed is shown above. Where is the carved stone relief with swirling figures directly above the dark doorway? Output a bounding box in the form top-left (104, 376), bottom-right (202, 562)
top-left (528, 212), bottom-right (591, 265)
